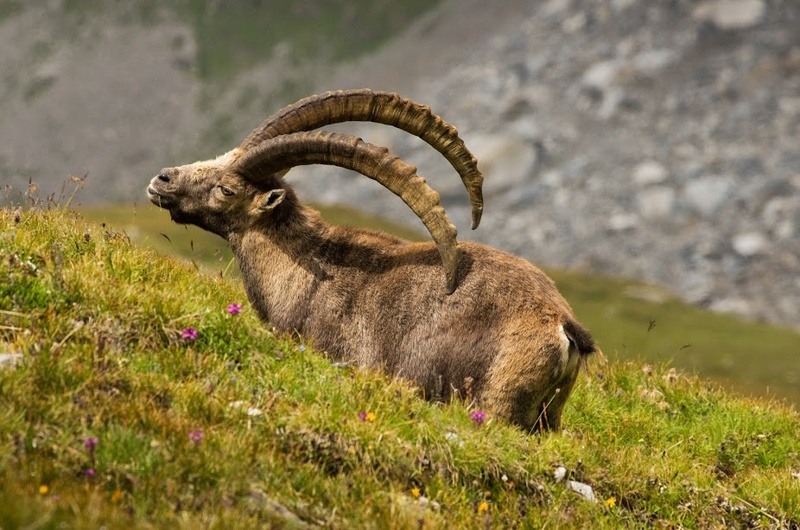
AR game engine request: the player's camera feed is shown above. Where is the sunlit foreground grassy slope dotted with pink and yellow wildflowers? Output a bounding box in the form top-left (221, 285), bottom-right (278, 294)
top-left (0, 209), bottom-right (800, 528)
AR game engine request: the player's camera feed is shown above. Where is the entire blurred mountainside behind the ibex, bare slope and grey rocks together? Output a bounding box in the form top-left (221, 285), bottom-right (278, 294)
top-left (0, 0), bottom-right (800, 327)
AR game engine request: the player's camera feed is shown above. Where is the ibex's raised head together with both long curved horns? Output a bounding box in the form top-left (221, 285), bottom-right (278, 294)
top-left (147, 89), bottom-right (483, 294)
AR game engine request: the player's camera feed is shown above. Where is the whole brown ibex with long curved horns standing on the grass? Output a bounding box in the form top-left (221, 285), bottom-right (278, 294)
top-left (147, 89), bottom-right (600, 430)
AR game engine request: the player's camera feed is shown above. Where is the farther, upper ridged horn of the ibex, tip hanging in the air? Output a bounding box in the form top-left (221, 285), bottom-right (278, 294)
top-left (239, 88), bottom-right (483, 230)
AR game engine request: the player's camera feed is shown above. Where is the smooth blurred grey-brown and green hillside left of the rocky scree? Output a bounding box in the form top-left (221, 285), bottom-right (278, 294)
top-left (0, 0), bottom-right (444, 203)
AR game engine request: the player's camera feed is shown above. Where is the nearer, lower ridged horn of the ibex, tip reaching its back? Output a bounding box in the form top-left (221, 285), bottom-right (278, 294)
top-left (231, 132), bottom-right (460, 294)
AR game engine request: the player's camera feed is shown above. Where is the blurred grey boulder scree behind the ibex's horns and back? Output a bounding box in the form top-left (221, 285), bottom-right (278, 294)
top-left (295, 0), bottom-right (800, 327)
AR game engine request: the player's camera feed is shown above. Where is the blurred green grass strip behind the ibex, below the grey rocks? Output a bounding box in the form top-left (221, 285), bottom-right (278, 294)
top-left (80, 205), bottom-right (800, 405)
